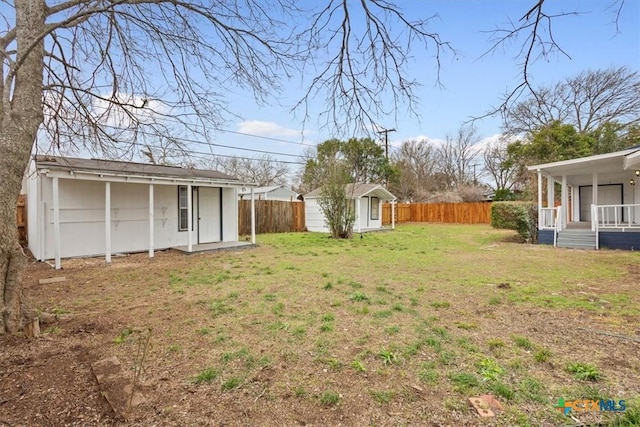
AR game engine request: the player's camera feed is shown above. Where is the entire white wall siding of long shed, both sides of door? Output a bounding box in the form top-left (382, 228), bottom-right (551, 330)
top-left (26, 175), bottom-right (238, 260)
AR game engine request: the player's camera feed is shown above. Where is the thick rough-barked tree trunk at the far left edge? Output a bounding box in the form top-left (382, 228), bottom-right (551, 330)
top-left (0, 0), bottom-right (46, 334)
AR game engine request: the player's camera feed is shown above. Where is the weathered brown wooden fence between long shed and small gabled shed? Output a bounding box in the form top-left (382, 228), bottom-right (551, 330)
top-left (238, 200), bottom-right (305, 236)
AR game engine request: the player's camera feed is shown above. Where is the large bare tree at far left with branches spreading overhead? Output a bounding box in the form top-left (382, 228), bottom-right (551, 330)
top-left (0, 0), bottom-right (447, 333)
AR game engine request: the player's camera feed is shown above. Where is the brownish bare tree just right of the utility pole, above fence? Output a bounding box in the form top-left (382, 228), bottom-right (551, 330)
top-left (390, 139), bottom-right (437, 202)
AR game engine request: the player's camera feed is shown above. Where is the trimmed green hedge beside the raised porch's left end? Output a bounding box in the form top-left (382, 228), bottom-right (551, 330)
top-left (491, 202), bottom-right (538, 243)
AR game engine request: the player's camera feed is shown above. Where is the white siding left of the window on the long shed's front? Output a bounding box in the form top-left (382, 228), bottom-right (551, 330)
top-left (35, 177), bottom-right (187, 259)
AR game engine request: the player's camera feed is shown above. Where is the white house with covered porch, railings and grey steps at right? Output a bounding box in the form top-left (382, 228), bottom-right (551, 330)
top-left (528, 146), bottom-right (640, 250)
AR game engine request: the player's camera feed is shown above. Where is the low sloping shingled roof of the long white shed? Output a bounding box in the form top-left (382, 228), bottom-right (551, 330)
top-left (34, 155), bottom-right (239, 182)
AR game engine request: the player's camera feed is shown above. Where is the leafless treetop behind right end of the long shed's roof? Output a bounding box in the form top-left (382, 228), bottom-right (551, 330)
top-left (207, 154), bottom-right (289, 187)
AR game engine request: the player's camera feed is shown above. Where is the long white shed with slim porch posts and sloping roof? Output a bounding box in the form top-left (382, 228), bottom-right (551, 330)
top-left (25, 155), bottom-right (255, 268)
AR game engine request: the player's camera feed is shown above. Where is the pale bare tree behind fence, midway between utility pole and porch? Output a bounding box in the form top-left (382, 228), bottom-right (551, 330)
top-left (437, 125), bottom-right (480, 189)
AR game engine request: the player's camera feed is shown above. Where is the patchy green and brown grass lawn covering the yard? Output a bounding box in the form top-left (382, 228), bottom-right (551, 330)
top-left (6, 224), bottom-right (640, 426)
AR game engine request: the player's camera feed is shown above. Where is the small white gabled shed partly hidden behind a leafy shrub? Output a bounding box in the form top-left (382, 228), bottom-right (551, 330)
top-left (304, 183), bottom-right (396, 233)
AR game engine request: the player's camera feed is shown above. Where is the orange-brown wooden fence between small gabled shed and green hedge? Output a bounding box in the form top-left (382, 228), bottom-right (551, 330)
top-left (382, 202), bottom-right (491, 225)
